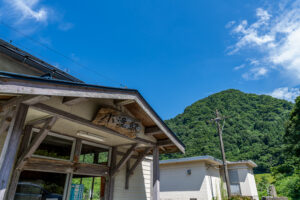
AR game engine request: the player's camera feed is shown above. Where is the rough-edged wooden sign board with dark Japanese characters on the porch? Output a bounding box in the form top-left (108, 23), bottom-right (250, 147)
top-left (93, 108), bottom-right (145, 138)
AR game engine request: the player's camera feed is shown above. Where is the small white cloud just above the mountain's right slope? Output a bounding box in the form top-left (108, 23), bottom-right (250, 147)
top-left (268, 87), bottom-right (300, 102)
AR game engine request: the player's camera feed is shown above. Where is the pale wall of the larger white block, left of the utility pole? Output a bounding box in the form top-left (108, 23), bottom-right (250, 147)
top-left (160, 162), bottom-right (213, 200)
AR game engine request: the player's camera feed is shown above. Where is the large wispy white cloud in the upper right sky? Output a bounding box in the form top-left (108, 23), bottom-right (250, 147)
top-left (229, 0), bottom-right (300, 84)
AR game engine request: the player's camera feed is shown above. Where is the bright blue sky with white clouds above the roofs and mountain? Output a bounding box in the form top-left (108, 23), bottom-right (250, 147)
top-left (0, 0), bottom-right (300, 119)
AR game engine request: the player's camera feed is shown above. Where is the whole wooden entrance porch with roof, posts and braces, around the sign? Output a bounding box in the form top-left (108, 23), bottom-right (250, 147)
top-left (0, 72), bottom-right (185, 200)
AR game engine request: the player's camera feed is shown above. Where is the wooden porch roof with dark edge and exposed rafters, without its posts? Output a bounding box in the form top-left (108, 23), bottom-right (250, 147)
top-left (0, 72), bottom-right (185, 153)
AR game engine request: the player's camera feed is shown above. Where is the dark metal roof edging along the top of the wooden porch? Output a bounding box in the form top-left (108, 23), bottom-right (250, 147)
top-left (0, 71), bottom-right (185, 148)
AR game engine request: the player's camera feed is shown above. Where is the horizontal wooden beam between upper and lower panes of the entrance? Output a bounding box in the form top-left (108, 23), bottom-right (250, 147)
top-left (23, 157), bottom-right (109, 176)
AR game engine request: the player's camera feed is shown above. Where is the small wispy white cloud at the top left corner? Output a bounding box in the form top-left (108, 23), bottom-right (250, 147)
top-left (5, 0), bottom-right (48, 22)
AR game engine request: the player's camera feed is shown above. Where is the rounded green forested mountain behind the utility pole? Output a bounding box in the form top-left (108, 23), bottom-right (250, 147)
top-left (163, 89), bottom-right (293, 172)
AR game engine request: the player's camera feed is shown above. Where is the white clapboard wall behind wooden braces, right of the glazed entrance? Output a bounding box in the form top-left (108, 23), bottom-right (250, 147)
top-left (114, 156), bottom-right (152, 200)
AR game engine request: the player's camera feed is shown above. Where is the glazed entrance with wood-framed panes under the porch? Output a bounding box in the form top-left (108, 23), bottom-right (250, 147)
top-left (14, 130), bottom-right (110, 200)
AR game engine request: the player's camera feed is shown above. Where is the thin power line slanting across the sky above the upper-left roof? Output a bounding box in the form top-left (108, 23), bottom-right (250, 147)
top-left (0, 21), bottom-right (127, 88)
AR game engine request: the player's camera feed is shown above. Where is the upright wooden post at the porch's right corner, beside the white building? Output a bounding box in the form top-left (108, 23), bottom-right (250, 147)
top-left (152, 146), bottom-right (160, 200)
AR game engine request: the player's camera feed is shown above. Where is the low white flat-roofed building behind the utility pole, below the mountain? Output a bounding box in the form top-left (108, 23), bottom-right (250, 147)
top-left (160, 156), bottom-right (258, 200)
